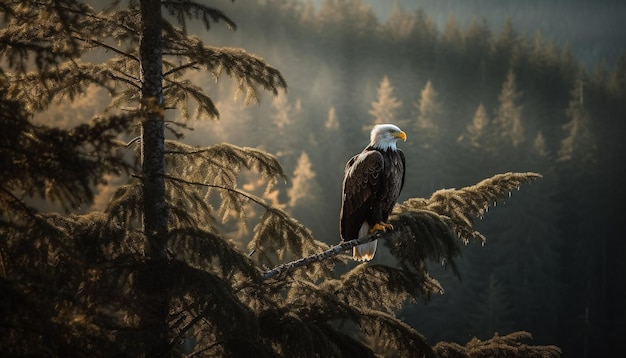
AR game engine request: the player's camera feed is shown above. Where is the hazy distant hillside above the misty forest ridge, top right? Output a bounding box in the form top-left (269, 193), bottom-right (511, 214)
top-left (366, 0), bottom-right (626, 69)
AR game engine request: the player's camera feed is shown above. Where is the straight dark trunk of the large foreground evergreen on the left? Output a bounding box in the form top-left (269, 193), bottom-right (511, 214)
top-left (136, 0), bottom-right (170, 357)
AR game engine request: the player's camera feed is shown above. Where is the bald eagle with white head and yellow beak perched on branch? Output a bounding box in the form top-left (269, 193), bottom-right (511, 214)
top-left (339, 124), bottom-right (406, 261)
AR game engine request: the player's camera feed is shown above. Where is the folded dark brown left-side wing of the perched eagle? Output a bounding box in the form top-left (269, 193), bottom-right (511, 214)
top-left (340, 150), bottom-right (384, 240)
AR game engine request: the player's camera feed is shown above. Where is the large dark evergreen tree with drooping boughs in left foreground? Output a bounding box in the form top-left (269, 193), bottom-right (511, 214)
top-left (0, 0), bottom-right (285, 355)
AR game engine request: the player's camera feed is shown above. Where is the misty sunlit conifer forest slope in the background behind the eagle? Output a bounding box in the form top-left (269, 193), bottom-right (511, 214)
top-left (6, 0), bottom-right (626, 357)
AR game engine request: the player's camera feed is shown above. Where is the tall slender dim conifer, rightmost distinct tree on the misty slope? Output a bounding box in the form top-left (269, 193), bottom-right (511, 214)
top-left (556, 74), bottom-right (607, 356)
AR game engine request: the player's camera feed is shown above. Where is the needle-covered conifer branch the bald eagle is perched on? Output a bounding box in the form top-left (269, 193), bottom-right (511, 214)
top-left (263, 173), bottom-right (542, 279)
